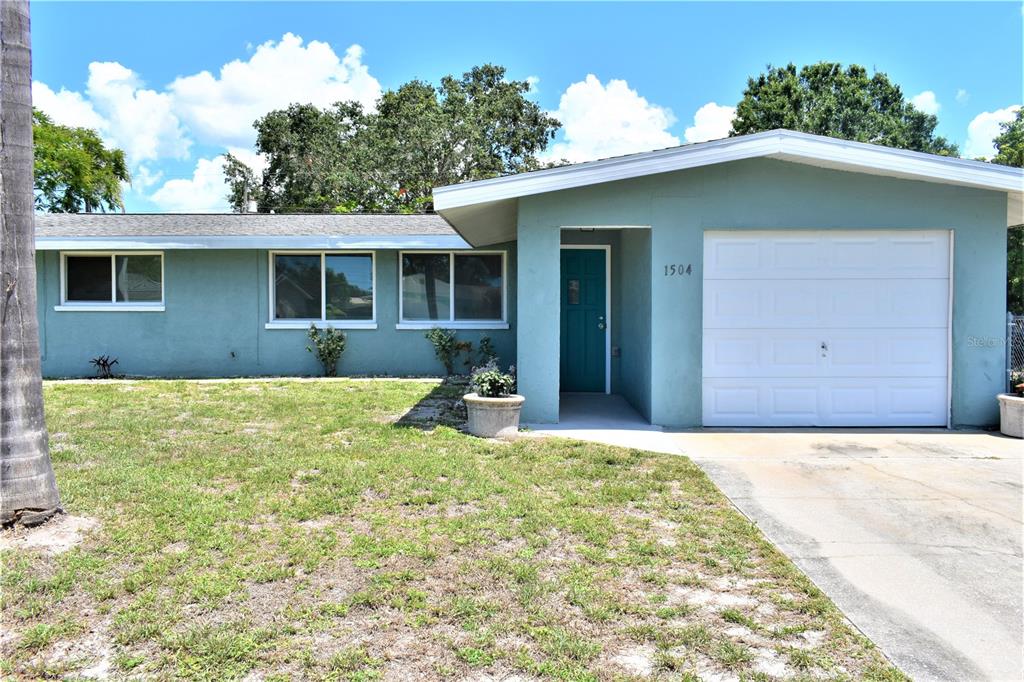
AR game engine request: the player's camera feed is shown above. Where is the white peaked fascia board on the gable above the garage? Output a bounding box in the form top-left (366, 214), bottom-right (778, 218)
top-left (434, 130), bottom-right (1024, 211)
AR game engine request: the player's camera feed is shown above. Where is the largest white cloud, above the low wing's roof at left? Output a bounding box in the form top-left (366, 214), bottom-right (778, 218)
top-left (33, 33), bottom-right (381, 211)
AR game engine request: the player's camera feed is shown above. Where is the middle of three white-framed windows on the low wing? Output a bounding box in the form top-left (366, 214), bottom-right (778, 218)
top-left (270, 251), bottom-right (375, 326)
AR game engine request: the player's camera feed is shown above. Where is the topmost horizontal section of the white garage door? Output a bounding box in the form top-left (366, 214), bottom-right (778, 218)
top-left (705, 230), bottom-right (949, 280)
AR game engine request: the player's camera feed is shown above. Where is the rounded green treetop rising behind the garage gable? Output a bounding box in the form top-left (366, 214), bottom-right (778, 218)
top-left (729, 61), bottom-right (957, 156)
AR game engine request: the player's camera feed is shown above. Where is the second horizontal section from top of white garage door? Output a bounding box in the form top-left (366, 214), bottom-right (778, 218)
top-left (703, 279), bottom-right (949, 329)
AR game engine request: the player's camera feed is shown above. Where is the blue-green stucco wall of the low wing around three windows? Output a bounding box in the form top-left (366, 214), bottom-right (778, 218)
top-left (36, 245), bottom-right (516, 377)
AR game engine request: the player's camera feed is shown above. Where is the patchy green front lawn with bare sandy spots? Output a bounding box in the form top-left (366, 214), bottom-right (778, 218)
top-left (0, 380), bottom-right (903, 680)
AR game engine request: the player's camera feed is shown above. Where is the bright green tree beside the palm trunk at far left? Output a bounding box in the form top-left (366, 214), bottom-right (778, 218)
top-left (32, 110), bottom-right (131, 213)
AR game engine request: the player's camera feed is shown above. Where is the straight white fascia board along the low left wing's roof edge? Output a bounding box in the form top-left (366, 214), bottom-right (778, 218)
top-left (36, 235), bottom-right (472, 251)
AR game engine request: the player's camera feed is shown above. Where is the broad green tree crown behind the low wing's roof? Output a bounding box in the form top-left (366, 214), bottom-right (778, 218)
top-left (224, 65), bottom-right (559, 213)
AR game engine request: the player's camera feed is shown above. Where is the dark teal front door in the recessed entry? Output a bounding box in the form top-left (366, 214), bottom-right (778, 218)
top-left (561, 249), bottom-right (608, 392)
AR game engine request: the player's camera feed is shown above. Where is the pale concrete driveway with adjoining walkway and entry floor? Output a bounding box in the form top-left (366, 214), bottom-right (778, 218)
top-left (534, 396), bottom-right (1024, 680)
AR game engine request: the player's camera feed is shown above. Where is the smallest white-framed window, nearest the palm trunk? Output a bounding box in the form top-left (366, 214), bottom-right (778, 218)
top-left (60, 251), bottom-right (164, 308)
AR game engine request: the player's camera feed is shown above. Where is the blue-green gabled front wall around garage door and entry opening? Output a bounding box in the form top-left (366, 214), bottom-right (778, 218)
top-left (517, 159), bottom-right (1007, 427)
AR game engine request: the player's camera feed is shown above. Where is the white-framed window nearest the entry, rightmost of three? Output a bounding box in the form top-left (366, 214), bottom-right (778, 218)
top-left (400, 251), bottom-right (506, 326)
